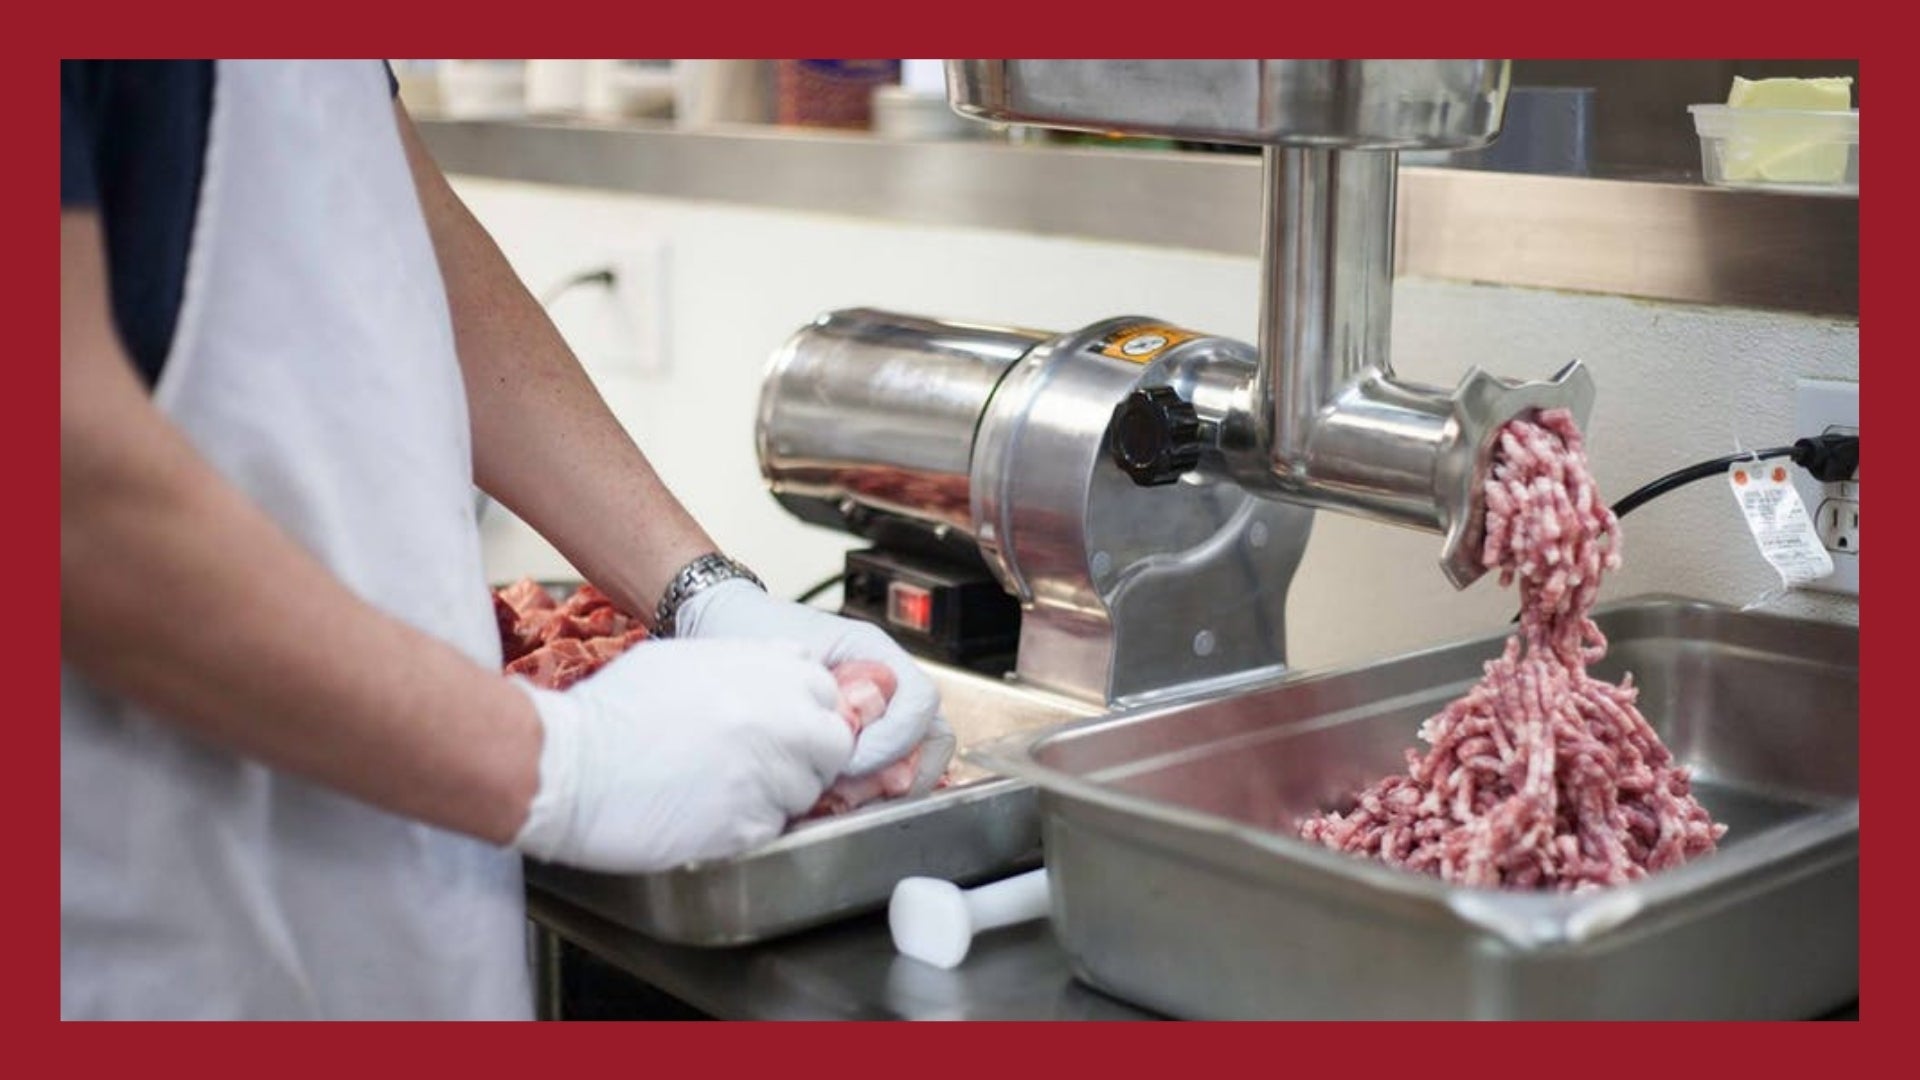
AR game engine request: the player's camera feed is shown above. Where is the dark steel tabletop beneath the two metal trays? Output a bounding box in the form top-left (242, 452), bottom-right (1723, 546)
top-left (526, 890), bottom-right (1860, 1020)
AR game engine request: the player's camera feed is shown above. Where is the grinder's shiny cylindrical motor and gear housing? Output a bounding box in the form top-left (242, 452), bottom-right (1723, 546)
top-left (756, 309), bottom-right (1311, 703)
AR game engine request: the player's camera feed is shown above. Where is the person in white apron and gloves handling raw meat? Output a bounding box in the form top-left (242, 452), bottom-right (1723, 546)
top-left (60, 61), bottom-right (950, 1019)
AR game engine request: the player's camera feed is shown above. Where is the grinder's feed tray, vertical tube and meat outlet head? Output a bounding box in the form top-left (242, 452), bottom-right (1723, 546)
top-left (947, 60), bottom-right (1594, 586)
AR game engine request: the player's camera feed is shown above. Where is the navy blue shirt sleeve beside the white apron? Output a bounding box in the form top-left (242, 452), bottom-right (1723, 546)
top-left (60, 60), bottom-right (397, 386)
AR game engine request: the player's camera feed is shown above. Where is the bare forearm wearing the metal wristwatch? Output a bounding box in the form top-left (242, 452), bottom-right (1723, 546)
top-left (396, 106), bottom-right (714, 619)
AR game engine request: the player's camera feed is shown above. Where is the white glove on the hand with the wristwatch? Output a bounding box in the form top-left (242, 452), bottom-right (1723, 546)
top-left (674, 580), bottom-right (954, 794)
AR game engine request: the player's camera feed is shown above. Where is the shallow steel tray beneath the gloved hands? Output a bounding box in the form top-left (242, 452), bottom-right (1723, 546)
top-left (526, 665), bottom-right (1096, 945)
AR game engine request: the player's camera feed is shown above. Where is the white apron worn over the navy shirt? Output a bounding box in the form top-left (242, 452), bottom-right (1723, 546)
top-left (60, 60), bottom-right (532, 1019)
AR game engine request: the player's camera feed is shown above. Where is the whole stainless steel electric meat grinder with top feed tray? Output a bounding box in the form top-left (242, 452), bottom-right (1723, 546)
top-left (756, 60), bottom-right (1594, 705)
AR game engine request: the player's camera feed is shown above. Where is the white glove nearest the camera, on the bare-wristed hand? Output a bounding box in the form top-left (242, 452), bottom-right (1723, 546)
top-left (513, 640), bottom-right (852, 872)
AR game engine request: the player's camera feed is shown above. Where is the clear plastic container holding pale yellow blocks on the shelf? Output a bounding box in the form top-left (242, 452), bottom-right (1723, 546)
top-left (1688, 106), bottom-right (1860, 196)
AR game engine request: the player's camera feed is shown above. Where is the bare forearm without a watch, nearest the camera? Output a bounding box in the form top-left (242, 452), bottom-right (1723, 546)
top-left (60, 213), bottom-right (540, 842)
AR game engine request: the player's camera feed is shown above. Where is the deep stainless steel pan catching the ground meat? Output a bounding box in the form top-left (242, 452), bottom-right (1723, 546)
top-left (979, 600), bottom-right (1860, 1019)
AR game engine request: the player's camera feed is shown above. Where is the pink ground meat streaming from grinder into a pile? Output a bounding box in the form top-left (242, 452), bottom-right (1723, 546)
top-left (1300, 409), bottom-right (1726, 890)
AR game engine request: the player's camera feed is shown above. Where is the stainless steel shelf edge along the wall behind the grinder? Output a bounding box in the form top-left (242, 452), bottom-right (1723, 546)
top-left (420, 119), bottom-right (1860, 317)
